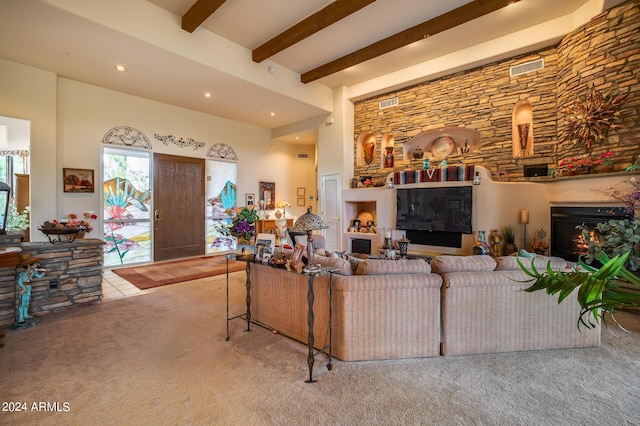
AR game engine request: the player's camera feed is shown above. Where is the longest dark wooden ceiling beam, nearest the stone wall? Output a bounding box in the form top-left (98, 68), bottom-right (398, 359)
top-left (300, 0), bottom-right (520, 83)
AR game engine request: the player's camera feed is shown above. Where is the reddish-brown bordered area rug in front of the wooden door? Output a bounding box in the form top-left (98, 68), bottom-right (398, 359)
top-left (113, 255), bottom-right (246, 290)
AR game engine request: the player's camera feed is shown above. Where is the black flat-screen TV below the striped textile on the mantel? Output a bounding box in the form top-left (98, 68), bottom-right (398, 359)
top-left (396, 186), bottom-right (473, 234)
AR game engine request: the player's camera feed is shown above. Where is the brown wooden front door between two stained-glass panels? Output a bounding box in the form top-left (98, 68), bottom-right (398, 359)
top-left (153, 154), bottom-right (205, 261)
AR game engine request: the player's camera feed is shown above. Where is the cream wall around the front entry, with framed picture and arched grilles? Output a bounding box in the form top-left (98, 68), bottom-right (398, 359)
top-left (0, 60), bottom-right (316, 241)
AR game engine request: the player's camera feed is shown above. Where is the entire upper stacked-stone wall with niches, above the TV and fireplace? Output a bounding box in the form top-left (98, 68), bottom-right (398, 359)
top-left (354, 0), bottom-right (640, 182)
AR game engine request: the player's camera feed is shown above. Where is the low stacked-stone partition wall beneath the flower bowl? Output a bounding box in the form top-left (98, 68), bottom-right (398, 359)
top-left (0, 239), bottom-right (104, 324)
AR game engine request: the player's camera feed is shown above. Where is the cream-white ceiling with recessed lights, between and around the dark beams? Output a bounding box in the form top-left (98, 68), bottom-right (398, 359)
top-left (0, 0), bottom-right (623, 143)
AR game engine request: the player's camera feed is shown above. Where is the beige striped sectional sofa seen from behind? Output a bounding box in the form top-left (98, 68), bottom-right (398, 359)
top-left (245, 251), bottom-right (600, 361)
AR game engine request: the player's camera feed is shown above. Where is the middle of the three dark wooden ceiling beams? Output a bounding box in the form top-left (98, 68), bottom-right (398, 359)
top-left (252, 0), bottom-right (375, 63)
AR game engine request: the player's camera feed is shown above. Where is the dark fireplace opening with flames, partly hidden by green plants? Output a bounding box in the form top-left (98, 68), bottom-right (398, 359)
top-left (550, 206), bottom-right (630, 262)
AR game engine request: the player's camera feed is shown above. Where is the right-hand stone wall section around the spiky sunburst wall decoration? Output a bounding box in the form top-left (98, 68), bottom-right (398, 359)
top-left (557, 0), bottom-right (640, 166)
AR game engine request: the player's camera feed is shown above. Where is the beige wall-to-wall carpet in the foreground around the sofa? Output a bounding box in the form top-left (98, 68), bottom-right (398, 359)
top-left (0, 272), bottom-right (640, 426)
